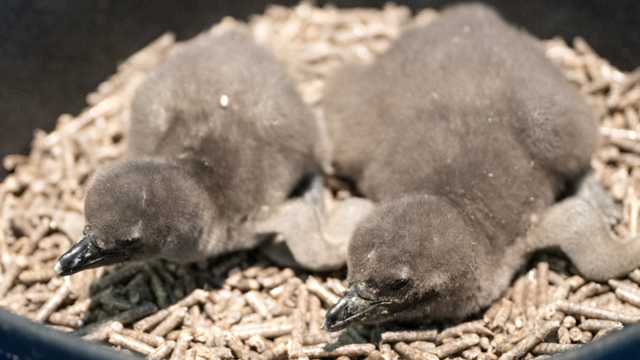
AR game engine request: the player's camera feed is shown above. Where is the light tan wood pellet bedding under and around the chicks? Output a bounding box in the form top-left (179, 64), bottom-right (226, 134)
top-left (0, 3), bottom-right (640, 360)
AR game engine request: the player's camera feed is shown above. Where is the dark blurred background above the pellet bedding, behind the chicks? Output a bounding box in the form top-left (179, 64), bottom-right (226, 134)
top-left (0, 0), bottom-right (640, 179)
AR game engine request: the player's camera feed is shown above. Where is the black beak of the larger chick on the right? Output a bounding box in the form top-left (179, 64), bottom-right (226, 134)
top-left (322, 287), bottom-right (390, 331)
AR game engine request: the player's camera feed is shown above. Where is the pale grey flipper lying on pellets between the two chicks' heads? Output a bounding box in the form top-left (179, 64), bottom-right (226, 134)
top-left (255, 198), bottom-right (373, 271)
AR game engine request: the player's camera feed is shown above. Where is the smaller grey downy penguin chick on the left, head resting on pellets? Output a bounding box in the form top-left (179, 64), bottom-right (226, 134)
top-left (55, 30), bottom-right (321, 276)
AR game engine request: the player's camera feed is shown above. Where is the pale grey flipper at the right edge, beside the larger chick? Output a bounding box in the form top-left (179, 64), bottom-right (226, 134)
top-left (526, 196), bottom-right (640, 281)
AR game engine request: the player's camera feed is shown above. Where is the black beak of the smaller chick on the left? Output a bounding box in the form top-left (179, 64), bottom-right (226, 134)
top-left (53, 236), bottom-right (127, 276)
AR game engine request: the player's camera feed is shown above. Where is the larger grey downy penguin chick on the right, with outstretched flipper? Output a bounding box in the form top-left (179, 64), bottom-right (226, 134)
top-left (324, 4), bottom-right (640, 331)
